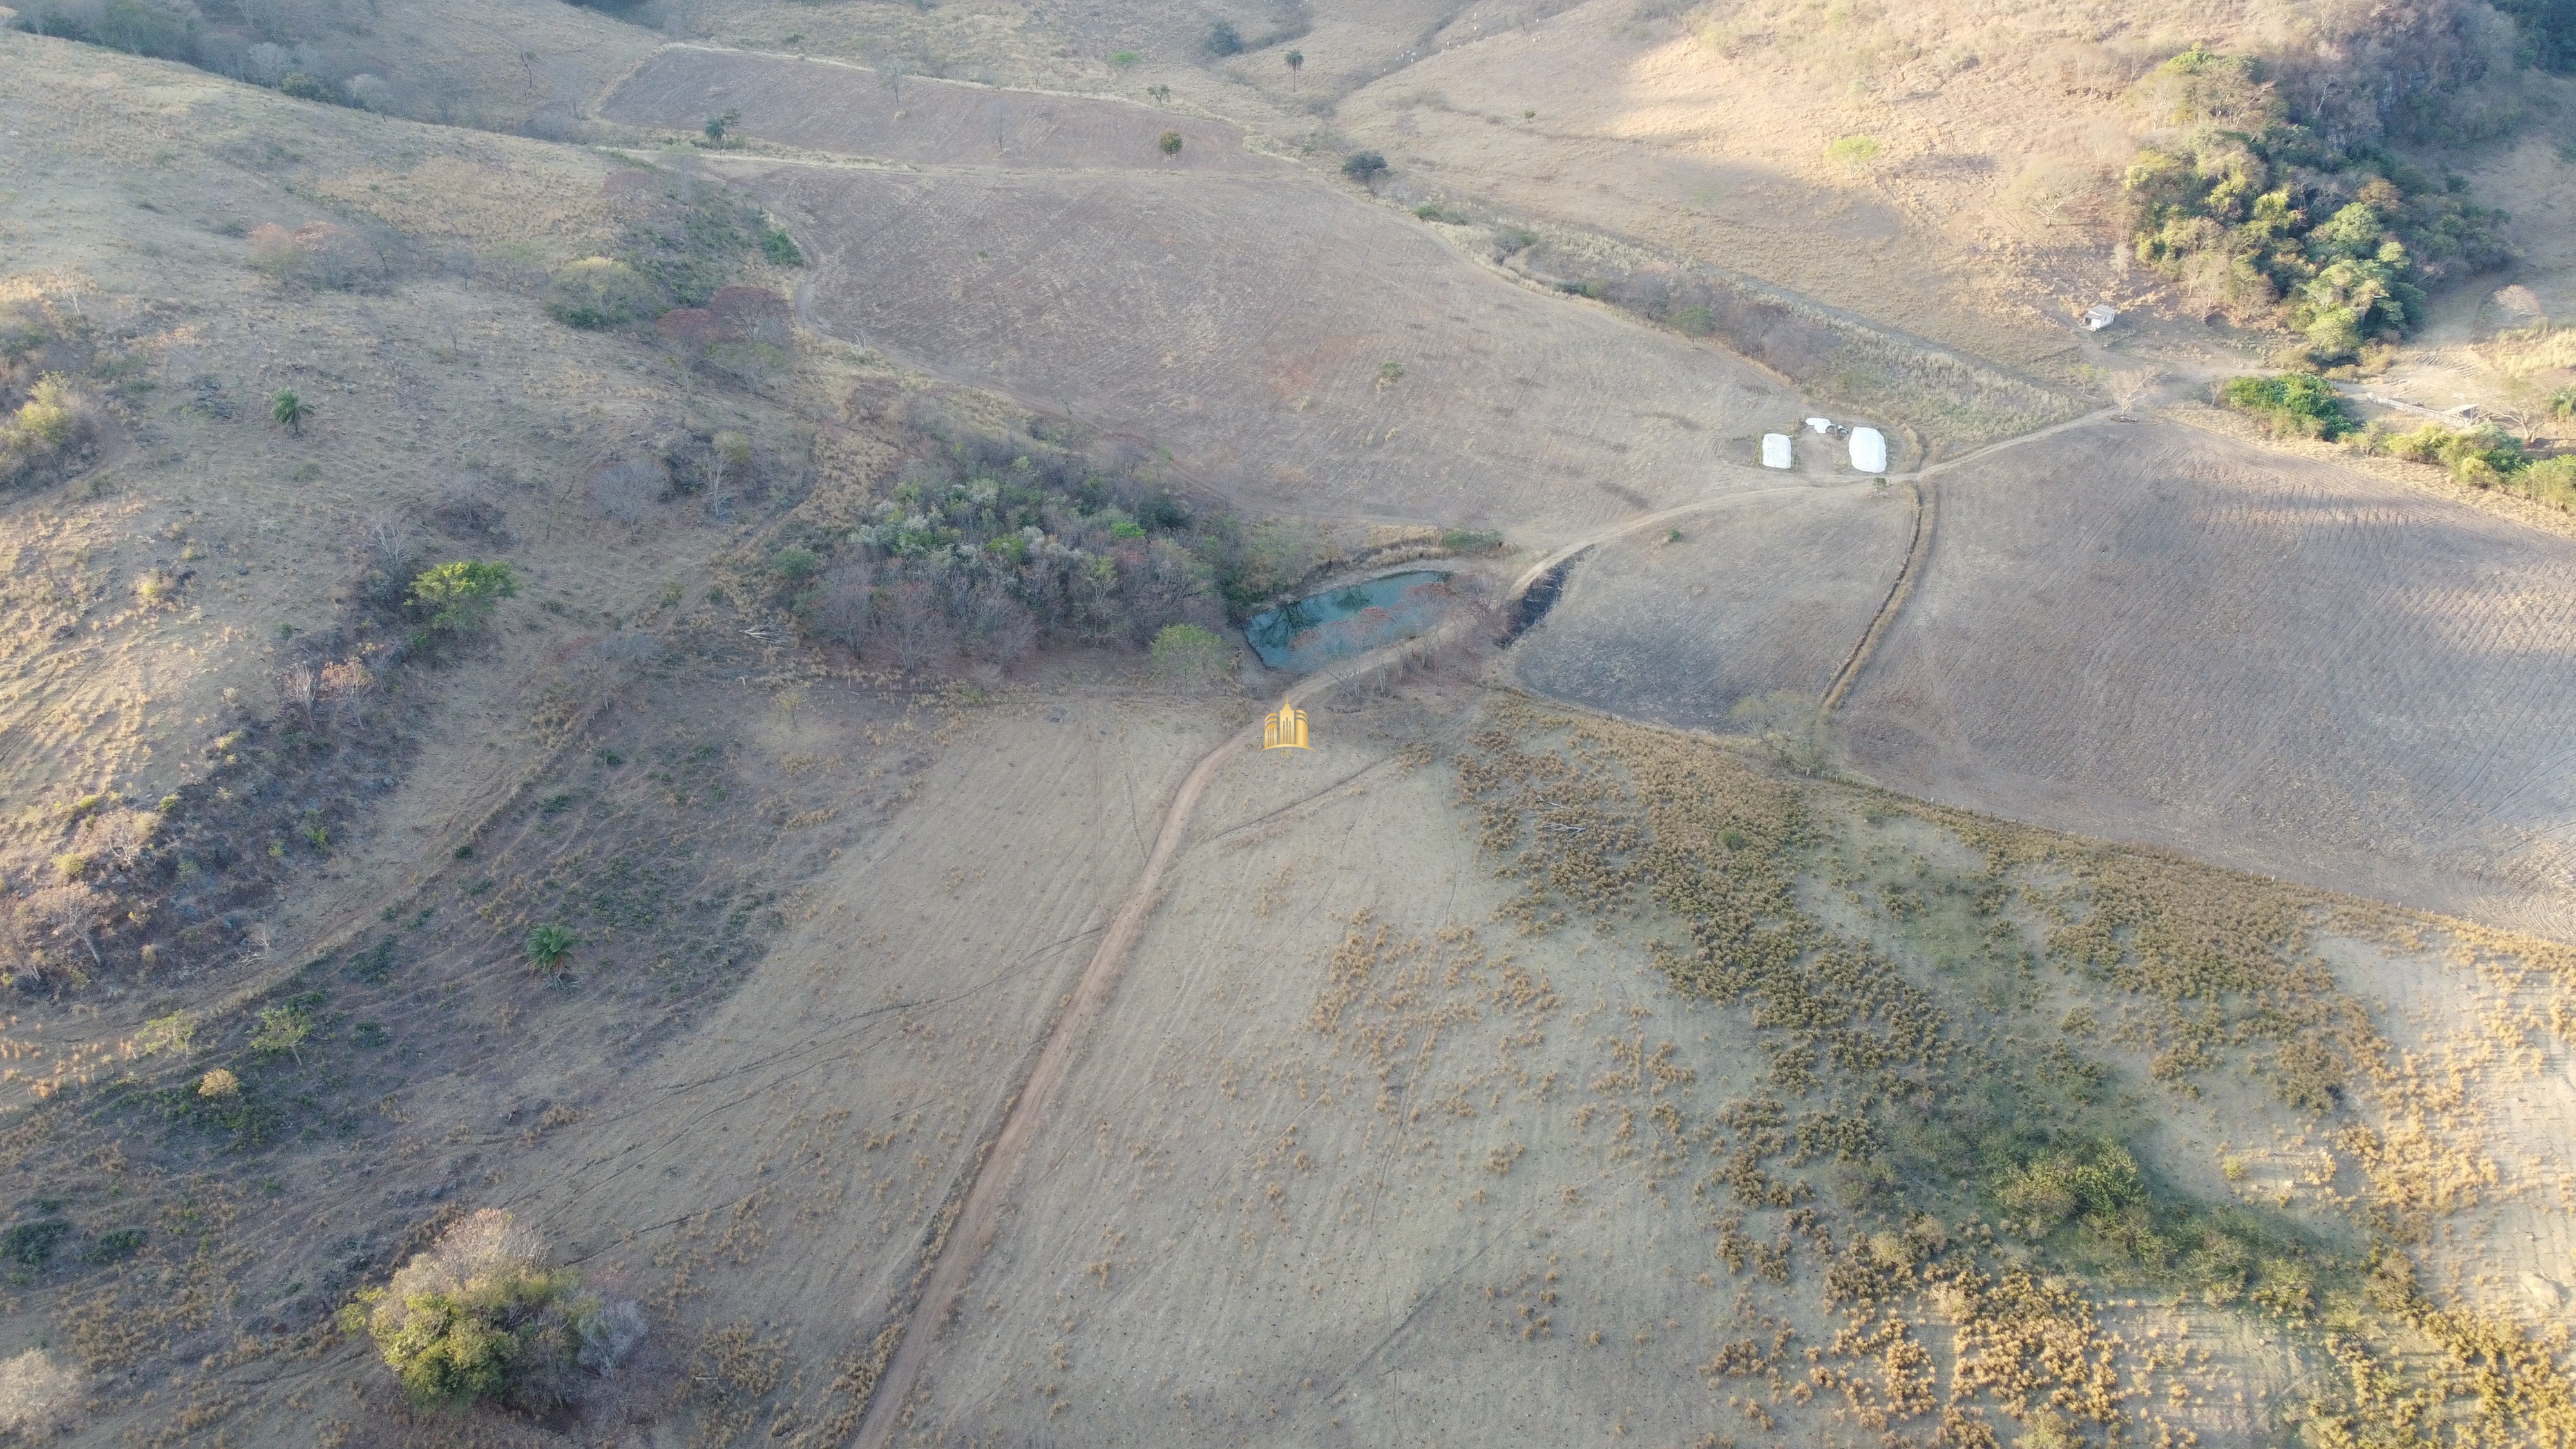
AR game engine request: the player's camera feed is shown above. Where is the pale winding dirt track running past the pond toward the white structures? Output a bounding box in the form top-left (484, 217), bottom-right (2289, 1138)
top-left (853, 409), bottom-right (2107, 1449)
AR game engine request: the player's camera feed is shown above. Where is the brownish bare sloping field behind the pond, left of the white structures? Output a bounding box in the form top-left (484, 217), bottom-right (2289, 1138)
top-left (747, 155), bottom-right (1798, 540)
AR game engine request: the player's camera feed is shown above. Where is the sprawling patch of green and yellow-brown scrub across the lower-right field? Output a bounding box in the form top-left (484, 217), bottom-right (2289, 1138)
top-left (1453, 700), bottom-right (2576, 1444)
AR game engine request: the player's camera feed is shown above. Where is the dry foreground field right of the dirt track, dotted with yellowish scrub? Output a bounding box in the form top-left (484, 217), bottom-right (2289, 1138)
top-left (855, 690), bottom-right (2576, 1446)
